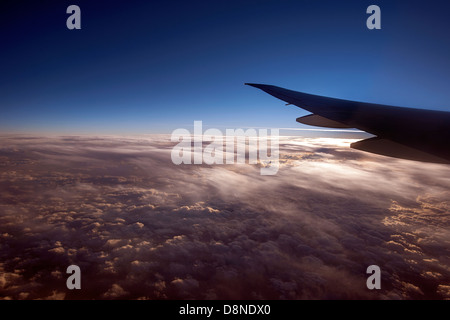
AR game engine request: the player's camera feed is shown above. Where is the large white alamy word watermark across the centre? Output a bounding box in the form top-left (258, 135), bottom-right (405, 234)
top-left (171, 121), bottom-right (279, 175)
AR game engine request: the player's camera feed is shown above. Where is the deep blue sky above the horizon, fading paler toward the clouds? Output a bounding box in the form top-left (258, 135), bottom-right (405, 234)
top-left (0, 0), bottom-right (450, 133)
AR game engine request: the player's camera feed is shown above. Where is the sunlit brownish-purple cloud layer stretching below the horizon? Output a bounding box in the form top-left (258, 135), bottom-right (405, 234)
top-left (0, 136), bottom-right (450, 299)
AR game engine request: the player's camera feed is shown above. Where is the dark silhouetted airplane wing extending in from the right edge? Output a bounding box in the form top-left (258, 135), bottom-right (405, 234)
top-left (246, 83), bottom-right (450, 164)
